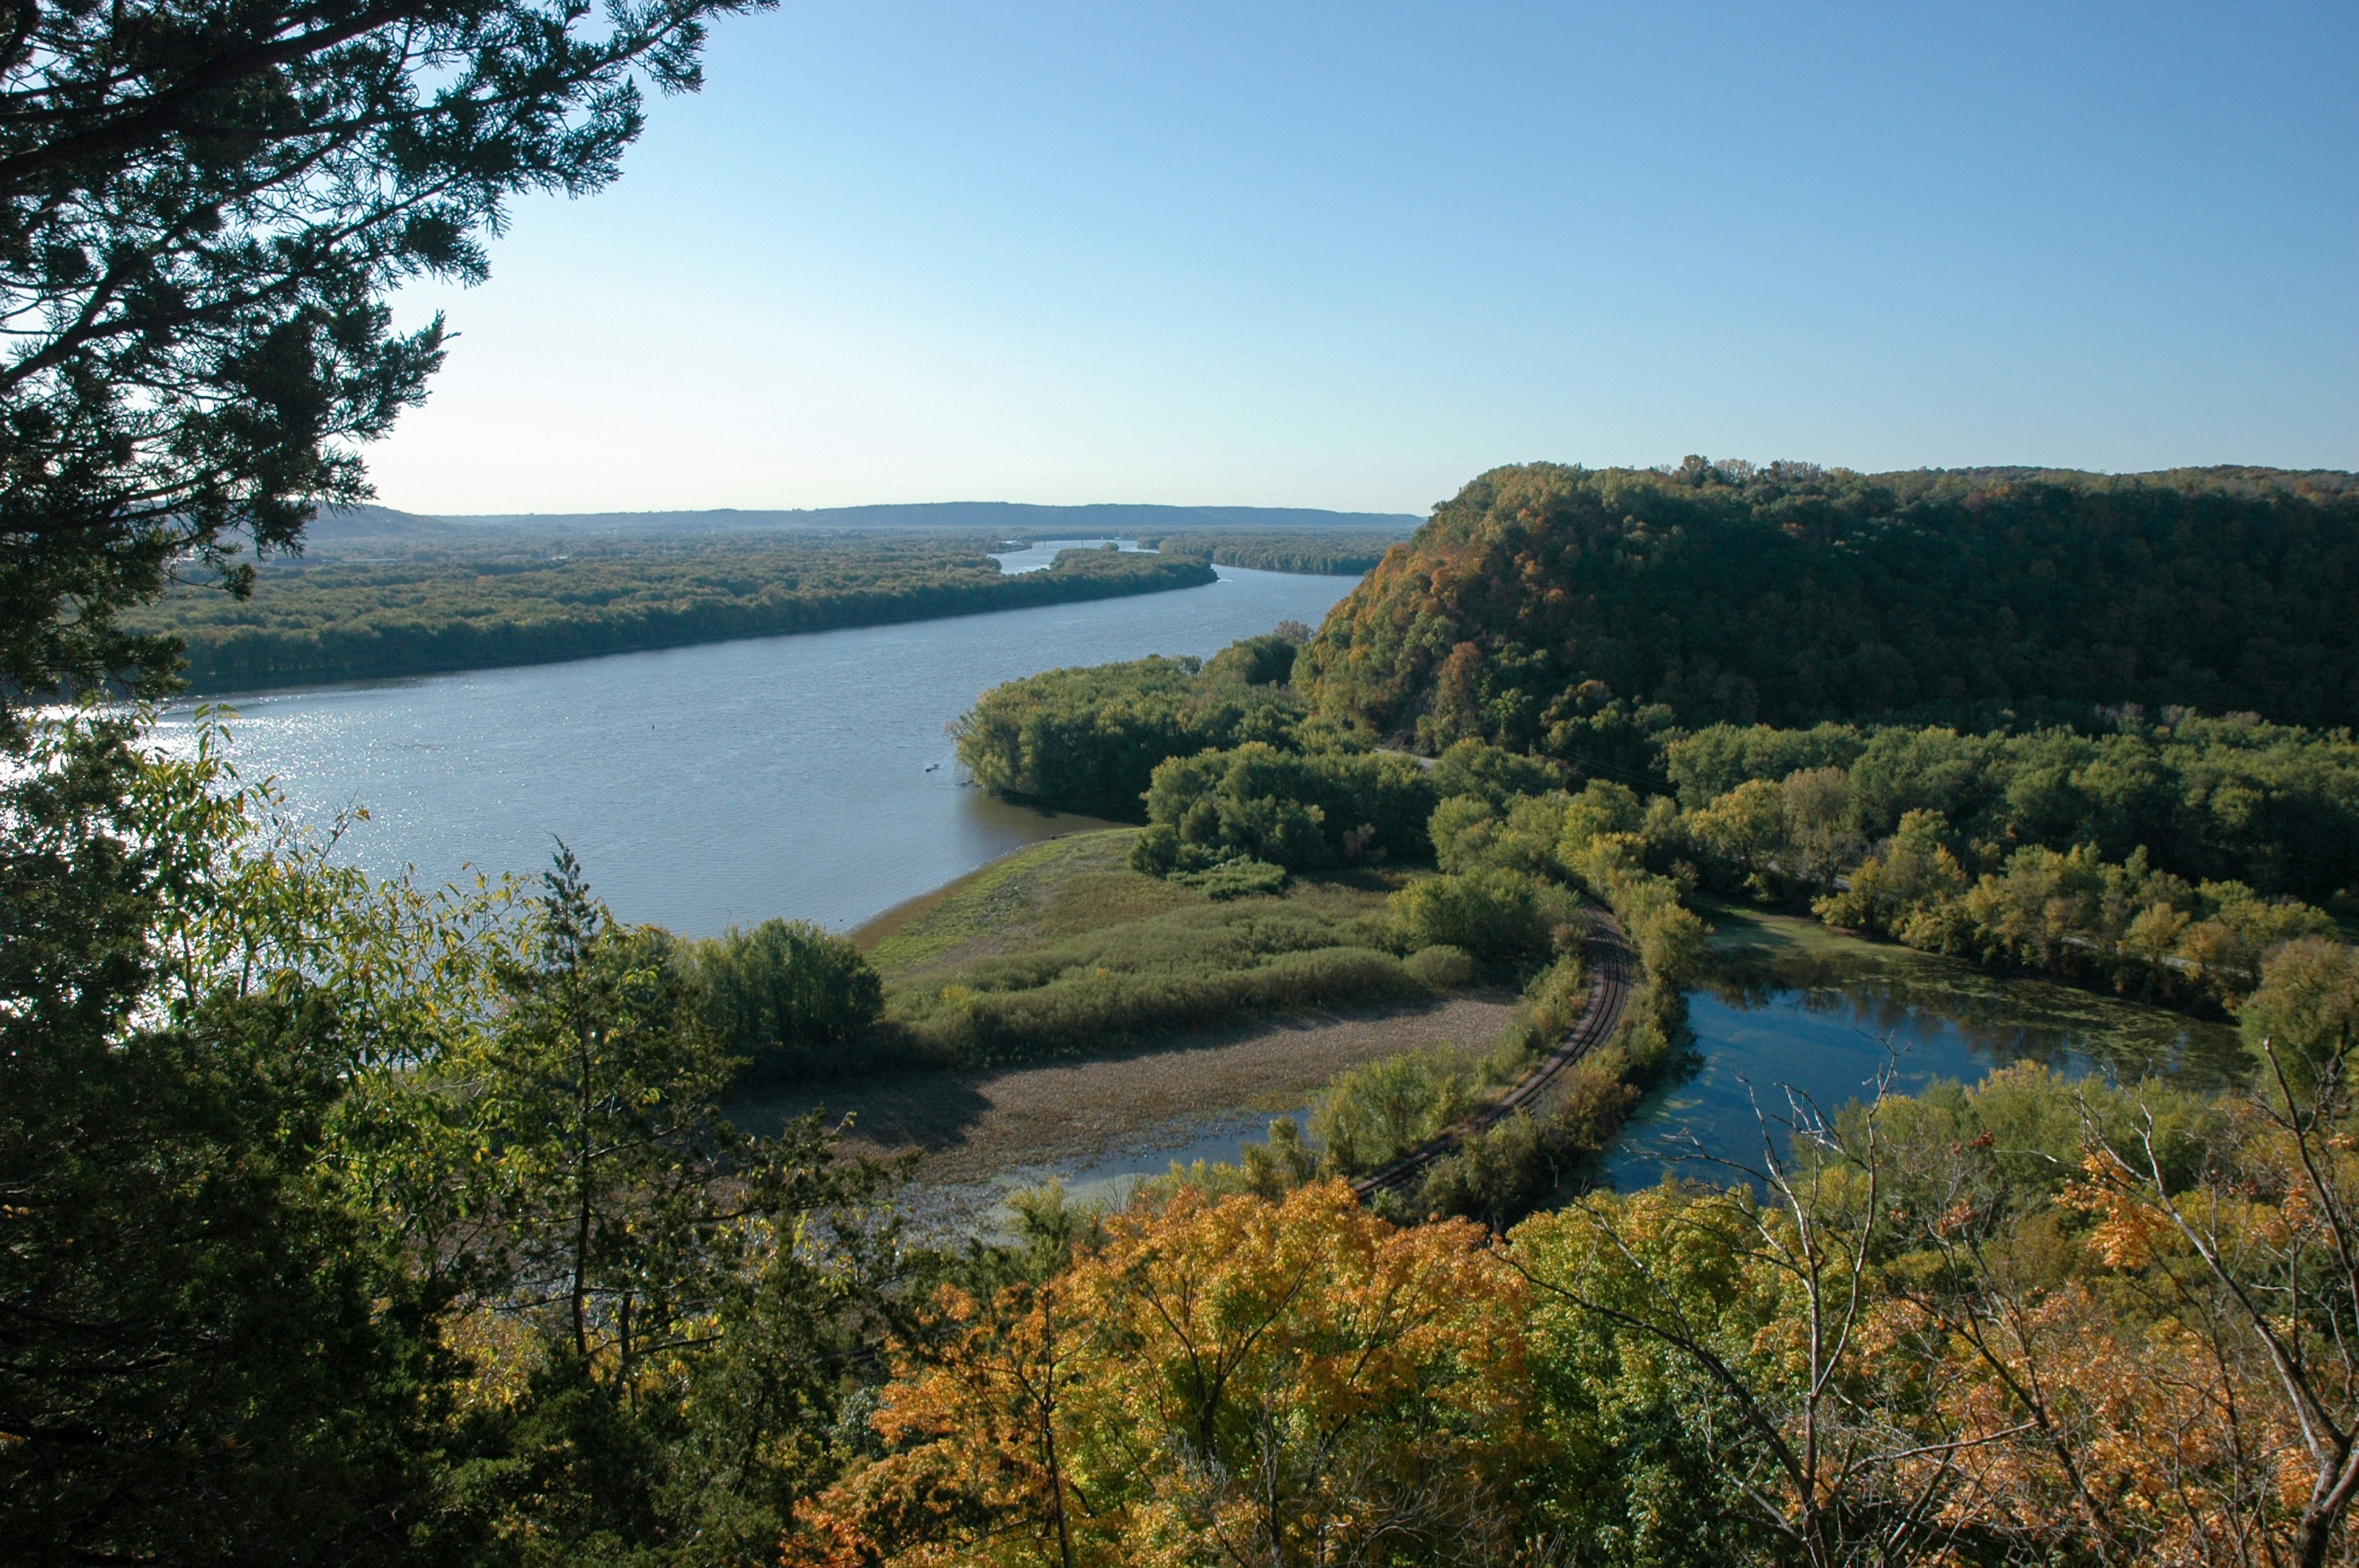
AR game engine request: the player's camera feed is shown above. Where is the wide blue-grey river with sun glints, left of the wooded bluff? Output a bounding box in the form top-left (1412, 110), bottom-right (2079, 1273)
top-left (163, 556), bottom-right (1354, 936)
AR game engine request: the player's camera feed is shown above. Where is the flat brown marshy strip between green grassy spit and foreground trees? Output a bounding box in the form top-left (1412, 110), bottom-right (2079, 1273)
top-left (741, 990), bottom-right (1514, 1186)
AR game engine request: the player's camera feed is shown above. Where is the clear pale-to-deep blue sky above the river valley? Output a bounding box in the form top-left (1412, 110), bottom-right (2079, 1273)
top-left (370, 0), bottom-right (2359, 512)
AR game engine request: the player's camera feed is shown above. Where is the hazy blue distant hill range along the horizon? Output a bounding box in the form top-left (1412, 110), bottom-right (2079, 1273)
top-left (309, 500), bottom-right (1425, 542)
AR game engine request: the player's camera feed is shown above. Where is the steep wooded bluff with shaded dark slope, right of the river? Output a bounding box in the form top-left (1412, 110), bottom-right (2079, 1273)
top-left (1297, 458), bottom-right (2359, 757)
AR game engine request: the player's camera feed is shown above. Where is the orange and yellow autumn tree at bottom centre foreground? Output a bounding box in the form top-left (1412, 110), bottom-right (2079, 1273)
top-left (788, 1181), bottom-right (1528, 1568)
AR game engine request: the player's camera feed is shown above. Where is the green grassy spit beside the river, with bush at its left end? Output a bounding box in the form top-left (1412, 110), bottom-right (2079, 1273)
top-left (670, 828), bottom-right (1474, 1085)
